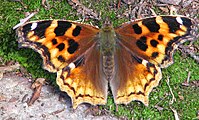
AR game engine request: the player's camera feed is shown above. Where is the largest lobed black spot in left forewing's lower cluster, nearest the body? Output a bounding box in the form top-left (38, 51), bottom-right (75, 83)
top-left (68, 39), bottom-right (79, 54)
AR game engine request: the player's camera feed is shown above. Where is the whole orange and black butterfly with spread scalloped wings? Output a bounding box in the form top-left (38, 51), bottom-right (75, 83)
top-left (17, 16), bottom-right (196, 108)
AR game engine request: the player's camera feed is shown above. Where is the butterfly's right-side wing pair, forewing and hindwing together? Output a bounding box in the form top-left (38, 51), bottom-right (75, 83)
top-left (110, 16), bottom-right (196, 105)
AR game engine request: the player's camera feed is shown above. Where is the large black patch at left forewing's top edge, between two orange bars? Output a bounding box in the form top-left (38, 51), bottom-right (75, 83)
top-left (54, 21), bottom-right (72, 36)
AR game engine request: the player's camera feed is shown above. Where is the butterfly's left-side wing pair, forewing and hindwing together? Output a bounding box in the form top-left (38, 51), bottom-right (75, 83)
top-left (17, 20), bottom-right (108, 108)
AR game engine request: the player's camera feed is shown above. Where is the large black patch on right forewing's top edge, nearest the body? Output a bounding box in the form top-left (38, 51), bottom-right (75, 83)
top-left (142, 17), bottom-right (160, 32)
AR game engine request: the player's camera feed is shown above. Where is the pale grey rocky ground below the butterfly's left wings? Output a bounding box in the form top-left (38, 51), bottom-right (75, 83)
top-left (0, 72), bottom-right (117, 120)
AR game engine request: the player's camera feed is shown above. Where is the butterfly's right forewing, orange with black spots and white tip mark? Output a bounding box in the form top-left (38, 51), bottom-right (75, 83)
top-left (115, 16), bottom-right (192, 67)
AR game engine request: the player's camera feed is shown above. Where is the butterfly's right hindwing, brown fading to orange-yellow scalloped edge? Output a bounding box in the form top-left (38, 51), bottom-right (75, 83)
top-left (110, 43), bottom-right (162, 105)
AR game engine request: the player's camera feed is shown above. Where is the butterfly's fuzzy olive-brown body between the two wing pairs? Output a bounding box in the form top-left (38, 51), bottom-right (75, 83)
top-left (99, 24), bottom-right (116, 80)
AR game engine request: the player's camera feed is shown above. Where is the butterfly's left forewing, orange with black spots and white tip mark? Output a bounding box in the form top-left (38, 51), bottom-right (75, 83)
top-left (18, 20), bottom-right (99, 72)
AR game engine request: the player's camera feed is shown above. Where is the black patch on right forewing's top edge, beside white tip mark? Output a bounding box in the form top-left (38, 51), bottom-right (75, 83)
top-left (162, 16), bottom-right (180, 33)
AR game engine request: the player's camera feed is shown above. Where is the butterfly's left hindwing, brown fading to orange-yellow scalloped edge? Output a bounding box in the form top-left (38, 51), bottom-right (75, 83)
top-left (57, 44), bottom-right (108, 108)
